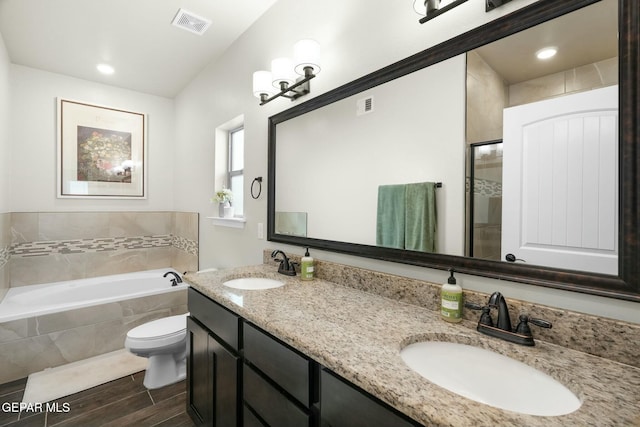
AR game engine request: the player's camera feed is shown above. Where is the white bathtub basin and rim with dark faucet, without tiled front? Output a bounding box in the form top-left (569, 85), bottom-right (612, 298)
top-left (0, 268), bottom-right (188, 323)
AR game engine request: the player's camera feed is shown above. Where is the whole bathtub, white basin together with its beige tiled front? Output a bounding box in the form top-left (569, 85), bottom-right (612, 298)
top-left (0, 268), bottom-right (188, 384)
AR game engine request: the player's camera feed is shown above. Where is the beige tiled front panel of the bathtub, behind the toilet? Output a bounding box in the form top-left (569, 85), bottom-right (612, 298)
top-left (0, 289), bottom-right (187, 384)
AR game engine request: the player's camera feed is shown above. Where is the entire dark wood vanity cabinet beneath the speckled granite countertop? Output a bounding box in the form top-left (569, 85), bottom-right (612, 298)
top-left (187, 289), bottom-right (418, 427)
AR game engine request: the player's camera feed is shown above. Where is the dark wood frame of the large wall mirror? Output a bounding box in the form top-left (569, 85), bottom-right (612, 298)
top-left (267, 0), bottom-right (640, 301)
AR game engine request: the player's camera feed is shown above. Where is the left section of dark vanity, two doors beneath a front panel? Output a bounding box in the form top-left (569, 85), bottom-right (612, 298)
top-left (187, 289), bottom-right (242, 427)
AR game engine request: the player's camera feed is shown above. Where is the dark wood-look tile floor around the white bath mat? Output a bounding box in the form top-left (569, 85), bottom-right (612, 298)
top-left (0, 371), bottom-right (194, 427)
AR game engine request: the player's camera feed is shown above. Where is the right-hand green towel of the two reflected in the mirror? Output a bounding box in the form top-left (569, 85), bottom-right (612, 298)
top-left (404, 182), bottom-right (437, 252)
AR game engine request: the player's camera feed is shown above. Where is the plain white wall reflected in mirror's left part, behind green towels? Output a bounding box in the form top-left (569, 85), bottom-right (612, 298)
top-left (275, 55), bottom-right (465, 255)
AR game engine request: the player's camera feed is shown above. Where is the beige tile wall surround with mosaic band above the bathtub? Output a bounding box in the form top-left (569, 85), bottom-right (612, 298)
top-left (7, 212), bottom-right (198, 286)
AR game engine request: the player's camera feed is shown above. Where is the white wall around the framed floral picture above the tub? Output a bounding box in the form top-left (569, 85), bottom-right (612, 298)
top-left (9, 64), bottom-right (176, 212)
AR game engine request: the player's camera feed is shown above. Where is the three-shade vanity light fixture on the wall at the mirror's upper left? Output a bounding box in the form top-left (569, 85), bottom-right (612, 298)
top-left (253, 39), bottom-right (320, 105)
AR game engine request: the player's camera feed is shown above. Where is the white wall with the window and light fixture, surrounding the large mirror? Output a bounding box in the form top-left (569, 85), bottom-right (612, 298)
top-left (151, 0), bottom-right (640, 323)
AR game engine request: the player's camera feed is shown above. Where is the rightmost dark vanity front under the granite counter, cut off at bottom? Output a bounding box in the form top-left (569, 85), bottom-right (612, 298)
top-left (320, 369), bottom-right (415, 427)
